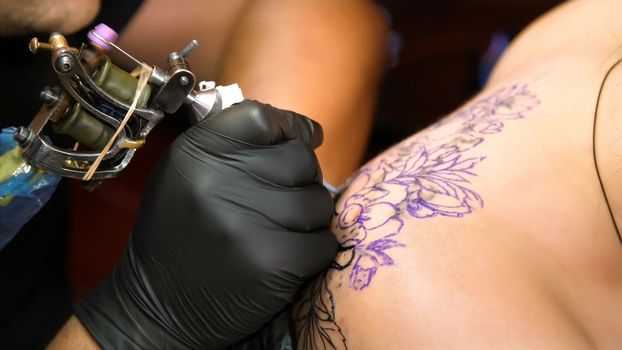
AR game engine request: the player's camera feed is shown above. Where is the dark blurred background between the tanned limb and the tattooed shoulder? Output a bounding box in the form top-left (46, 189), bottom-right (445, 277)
top-left (369, 0), bottom-right (562, 157)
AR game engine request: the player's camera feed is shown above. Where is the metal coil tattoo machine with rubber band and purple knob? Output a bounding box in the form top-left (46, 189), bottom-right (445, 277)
top-left (14, 24), bottom-right (243, 180)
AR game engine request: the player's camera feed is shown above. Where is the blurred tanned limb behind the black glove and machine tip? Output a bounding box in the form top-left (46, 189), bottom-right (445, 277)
top-left (218, 0), bottom-right (387, 183)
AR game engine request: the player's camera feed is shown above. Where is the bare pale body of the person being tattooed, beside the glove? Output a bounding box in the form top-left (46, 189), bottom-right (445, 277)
top-left (295, 0), bottom-right (622, 349)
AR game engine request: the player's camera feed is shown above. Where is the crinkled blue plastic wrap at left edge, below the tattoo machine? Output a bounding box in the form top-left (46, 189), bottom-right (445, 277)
top-left (0, 128), bottom-right (60, 250)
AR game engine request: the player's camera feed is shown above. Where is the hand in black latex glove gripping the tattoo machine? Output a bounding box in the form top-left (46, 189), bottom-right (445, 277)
top-left (76, 101), bottom-right (337, 349)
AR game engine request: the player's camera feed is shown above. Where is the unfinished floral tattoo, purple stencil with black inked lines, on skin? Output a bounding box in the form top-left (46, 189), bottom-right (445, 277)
top-left (295, 85), bottom-right (540, 349)
